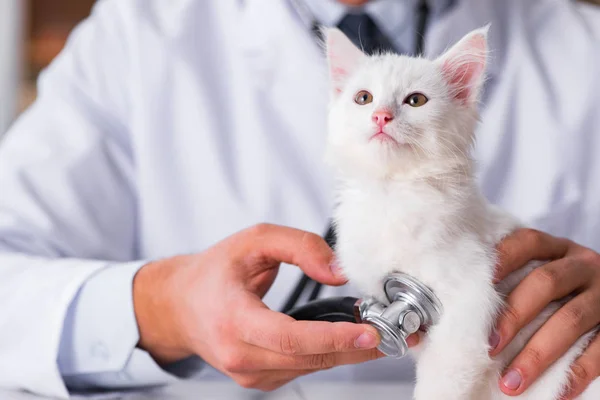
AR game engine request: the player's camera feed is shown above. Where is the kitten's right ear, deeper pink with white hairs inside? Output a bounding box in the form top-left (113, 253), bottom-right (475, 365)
top-left (437, 24), bottom-right (490, 104)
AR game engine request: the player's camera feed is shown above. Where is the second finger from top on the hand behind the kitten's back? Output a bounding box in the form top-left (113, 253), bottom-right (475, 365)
top-left (490, 258), bottom-right (593, 356)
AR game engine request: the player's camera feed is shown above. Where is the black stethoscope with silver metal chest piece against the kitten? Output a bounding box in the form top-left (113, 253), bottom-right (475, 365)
top-left (281, 0), bottom-right (442, 358)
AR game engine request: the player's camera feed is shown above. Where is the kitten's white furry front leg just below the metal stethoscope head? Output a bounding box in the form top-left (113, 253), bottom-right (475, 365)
top-left (414, 296), bottom-right (494, 400)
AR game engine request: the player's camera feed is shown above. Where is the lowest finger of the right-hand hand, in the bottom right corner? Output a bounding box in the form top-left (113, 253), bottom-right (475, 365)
top-left (561, 336), bottom-right (600, 400)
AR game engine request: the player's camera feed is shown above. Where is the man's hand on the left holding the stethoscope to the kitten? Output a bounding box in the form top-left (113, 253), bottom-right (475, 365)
top-left (133, 224), bottom-right (383, 390)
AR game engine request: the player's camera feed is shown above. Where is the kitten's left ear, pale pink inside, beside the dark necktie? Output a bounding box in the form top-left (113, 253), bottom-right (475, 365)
top-left (322, 28), bottom-right (366, 94)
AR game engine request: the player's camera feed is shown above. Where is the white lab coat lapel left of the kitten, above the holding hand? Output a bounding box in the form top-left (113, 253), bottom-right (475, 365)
top-left (234, 0), bottom-right (332, 309)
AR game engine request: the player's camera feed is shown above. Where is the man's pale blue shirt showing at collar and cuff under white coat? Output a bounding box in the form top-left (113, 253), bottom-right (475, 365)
top-left (57, 0), bottom-right (455, 387)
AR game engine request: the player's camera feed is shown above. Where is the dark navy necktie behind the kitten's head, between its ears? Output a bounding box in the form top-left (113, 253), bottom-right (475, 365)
top-left (338, 14), bottom-right (398, 54)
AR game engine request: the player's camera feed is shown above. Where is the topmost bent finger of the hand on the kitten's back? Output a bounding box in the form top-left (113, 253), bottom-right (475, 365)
top-left (495, 229), bottom-right (570, 282)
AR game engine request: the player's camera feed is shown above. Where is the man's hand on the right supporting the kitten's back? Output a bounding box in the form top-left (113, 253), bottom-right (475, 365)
top-left (490, 229), bottom-right (600, 400)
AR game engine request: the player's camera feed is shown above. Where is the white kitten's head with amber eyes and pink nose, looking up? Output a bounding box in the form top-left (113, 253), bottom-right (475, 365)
top-left (324, 26), bottom-right (488, 177)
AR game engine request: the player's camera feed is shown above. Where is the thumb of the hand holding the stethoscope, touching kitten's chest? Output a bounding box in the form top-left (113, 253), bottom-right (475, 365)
top-left (239, 224), bottom-right (346, 286)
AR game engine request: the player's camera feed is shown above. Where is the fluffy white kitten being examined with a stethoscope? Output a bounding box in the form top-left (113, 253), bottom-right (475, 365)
top-left (325, 27), bottom-right (600, 400)
